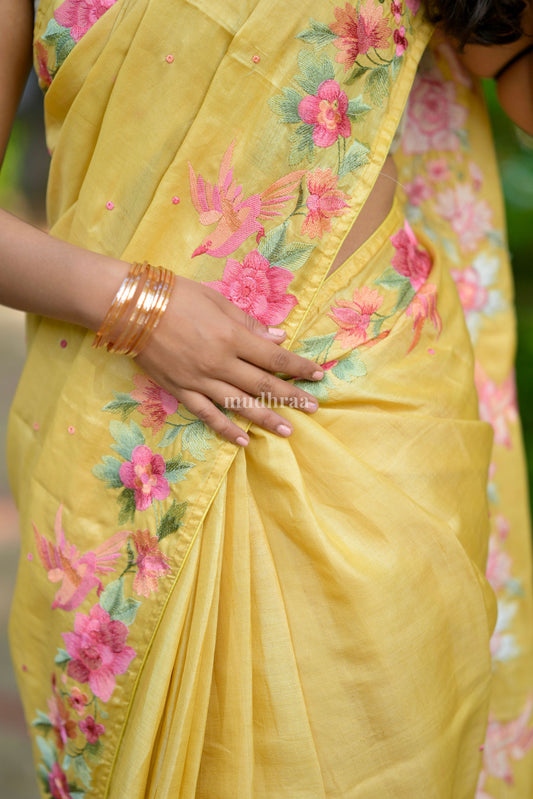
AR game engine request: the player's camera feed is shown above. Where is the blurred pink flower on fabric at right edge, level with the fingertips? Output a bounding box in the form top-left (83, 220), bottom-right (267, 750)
top-left (475, 362), bottom-right (518, 448)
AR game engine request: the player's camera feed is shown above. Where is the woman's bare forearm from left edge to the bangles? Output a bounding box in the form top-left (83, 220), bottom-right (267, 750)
top-left (0, 210), bottom-right (129, 330)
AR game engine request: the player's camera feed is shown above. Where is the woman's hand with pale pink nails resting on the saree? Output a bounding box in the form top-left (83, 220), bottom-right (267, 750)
top-left (136, 277), bottom-right (323, 446)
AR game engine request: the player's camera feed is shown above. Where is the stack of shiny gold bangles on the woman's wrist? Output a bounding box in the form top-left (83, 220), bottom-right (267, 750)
top-left (93, 261), bottom-right (174, 358)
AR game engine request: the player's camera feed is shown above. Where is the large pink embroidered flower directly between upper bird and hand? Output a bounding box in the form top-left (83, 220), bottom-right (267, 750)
top-left (205, 250), bottom-right (298, 325)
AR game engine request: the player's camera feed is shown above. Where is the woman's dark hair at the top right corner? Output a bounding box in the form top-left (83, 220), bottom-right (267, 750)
top-left (424, 0), bottom-right (527, 45)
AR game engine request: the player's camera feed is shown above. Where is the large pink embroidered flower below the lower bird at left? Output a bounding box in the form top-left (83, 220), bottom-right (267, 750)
top-left (63, 605), bottom-right (135, 702)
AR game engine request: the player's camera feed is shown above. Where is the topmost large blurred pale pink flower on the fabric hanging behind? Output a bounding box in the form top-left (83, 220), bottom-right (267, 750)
top-left (402, 69), bottom-right (467, 155)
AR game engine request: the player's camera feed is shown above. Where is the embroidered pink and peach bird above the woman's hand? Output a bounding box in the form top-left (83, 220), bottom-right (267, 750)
top-left (189, 141), bottom-right (305, 258)
